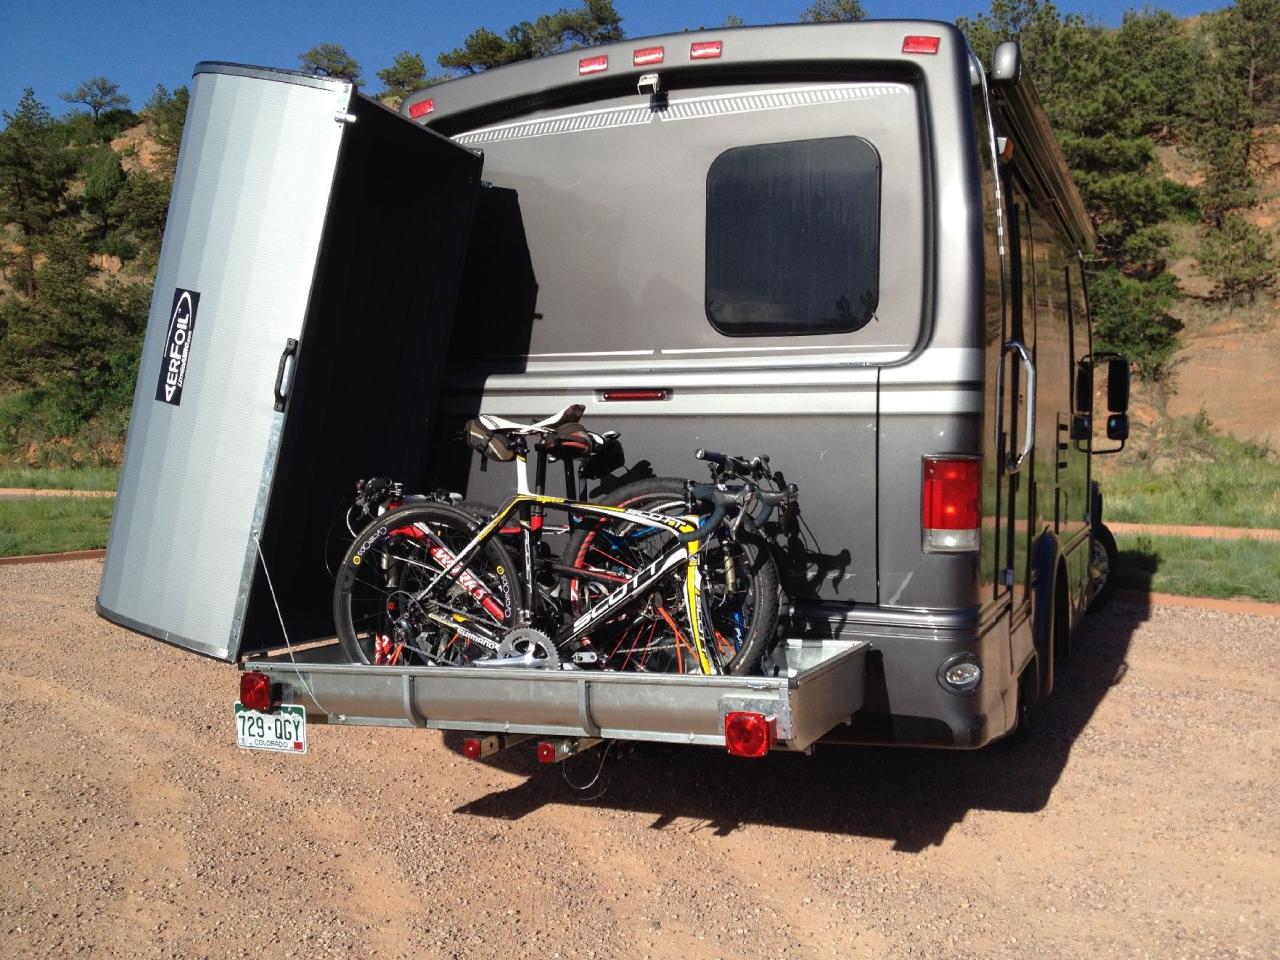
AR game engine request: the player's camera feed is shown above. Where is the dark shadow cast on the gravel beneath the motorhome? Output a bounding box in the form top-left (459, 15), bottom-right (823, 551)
top-left (451, 599), bottom-right (1149, 852)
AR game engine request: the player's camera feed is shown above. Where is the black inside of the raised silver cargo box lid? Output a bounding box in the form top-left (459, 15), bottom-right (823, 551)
top-left (241, 97), bottom-right (481, 654)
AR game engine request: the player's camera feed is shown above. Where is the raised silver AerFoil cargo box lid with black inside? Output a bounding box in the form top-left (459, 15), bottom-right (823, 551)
top-left (97, 63), bottom-right (481, 660)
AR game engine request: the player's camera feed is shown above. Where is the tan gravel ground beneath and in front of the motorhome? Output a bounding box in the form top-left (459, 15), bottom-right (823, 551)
top-left (0, 561), bottom-right (1280, 960)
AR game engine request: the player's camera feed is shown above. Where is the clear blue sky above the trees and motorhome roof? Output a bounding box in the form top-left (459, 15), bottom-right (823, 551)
top-left (0, 0), bottom-right (1224, 114)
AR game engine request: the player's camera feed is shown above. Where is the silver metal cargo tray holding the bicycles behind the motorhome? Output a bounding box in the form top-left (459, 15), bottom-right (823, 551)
top-left (241, 640), bottom-right (870, 751)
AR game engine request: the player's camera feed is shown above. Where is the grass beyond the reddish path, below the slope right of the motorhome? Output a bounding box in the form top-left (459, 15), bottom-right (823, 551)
top-left (1096, 415), bottom-right (1280, 530)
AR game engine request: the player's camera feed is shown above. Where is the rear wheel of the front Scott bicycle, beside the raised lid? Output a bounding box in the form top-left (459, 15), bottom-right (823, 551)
top-left (333, 503), bottom-right (520, 666)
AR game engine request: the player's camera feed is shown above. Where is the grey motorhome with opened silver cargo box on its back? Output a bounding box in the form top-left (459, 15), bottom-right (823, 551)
top-left (99, 20), bottom-right (1128, 759)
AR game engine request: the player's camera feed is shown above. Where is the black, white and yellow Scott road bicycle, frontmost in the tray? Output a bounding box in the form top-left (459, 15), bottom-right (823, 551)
top-left (334, 404), bottom-right (796, 675)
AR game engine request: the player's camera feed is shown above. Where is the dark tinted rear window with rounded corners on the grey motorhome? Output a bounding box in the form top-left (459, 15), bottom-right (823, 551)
top-left (707, 137), bottom-right (881, 337)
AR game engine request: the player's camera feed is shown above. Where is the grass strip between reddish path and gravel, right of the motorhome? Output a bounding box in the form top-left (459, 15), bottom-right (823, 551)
top-left (1115, 534), bottom-right (1280, 603)
